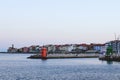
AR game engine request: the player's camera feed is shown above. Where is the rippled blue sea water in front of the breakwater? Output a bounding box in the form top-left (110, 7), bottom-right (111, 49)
top-left (0, 54), bottom-right (120, 80)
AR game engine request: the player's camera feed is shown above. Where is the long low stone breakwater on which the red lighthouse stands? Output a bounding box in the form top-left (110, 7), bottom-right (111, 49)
top-left (28, 54), bottom-right (99, 59)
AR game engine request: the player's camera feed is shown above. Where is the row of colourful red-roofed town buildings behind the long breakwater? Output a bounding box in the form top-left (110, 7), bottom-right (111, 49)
top-left (7, 43), bottom-right (105, 54)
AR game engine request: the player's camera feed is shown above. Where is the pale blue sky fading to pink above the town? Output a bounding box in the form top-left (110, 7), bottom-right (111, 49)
top-left (0, 0), bottom-right (120, 51)
